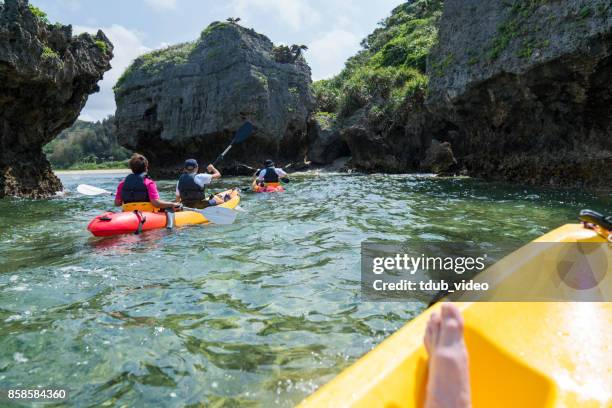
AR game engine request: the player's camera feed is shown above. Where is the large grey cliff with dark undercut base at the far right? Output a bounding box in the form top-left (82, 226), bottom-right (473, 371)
top-left (428, 0), bottom-right (612, 187)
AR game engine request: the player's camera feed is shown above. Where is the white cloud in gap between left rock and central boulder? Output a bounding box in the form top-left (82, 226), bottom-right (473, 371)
top-left (73, 24), bottom-right (151, 120)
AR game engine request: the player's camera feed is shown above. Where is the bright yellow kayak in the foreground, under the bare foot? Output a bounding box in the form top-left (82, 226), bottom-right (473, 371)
top-left (300, 224), bottom-right (612, 408)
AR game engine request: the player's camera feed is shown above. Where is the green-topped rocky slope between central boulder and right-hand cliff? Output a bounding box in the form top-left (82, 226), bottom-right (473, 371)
top-left (309, 0), bottom-right (446, 173)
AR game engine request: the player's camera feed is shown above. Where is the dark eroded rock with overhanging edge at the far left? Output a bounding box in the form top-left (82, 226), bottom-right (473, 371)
top-left (0, 0), bottom-right (113, 198)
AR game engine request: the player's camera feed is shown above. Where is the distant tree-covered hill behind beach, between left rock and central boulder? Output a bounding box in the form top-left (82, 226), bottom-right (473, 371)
top-left (43, 116), bottom-right (130, 169)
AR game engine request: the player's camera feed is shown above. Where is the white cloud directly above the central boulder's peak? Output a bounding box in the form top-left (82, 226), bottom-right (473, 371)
top-left (231, 0), bottom-right (321, 30)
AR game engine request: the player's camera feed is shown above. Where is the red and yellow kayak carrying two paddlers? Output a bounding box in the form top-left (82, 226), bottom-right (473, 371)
top-left (87, 189), bottom-right (240, 237)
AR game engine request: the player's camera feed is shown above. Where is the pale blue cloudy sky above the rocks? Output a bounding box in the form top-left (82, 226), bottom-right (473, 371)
top-left (30, 0), bottom-right (404, 121)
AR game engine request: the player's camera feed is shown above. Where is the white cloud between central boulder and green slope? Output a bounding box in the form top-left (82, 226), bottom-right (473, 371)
top-left (306, 29), bottom-right (361, 81)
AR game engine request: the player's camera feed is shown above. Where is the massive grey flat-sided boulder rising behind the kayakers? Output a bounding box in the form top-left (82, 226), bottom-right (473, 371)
top-left (115, 22), bottom-right (314, 175)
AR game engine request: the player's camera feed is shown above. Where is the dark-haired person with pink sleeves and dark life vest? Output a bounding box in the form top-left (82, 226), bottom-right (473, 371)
top-left (115, 153), bottom-right (181, 208)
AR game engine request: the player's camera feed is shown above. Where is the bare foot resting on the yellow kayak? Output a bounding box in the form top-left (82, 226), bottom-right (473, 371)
top-left (424, 304), bottom-right (472, 408)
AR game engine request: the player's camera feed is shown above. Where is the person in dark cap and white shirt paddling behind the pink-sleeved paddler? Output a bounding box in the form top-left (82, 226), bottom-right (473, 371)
top-left (176, 159), bottom-right (221, 208)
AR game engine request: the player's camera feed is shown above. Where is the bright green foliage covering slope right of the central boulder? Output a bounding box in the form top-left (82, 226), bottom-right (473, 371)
top-left (313, 0), bottom-right (442, 120)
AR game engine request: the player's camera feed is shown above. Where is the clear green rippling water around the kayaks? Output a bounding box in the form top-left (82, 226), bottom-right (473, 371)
top-left (0, 174), bottom-right (612, 406)
